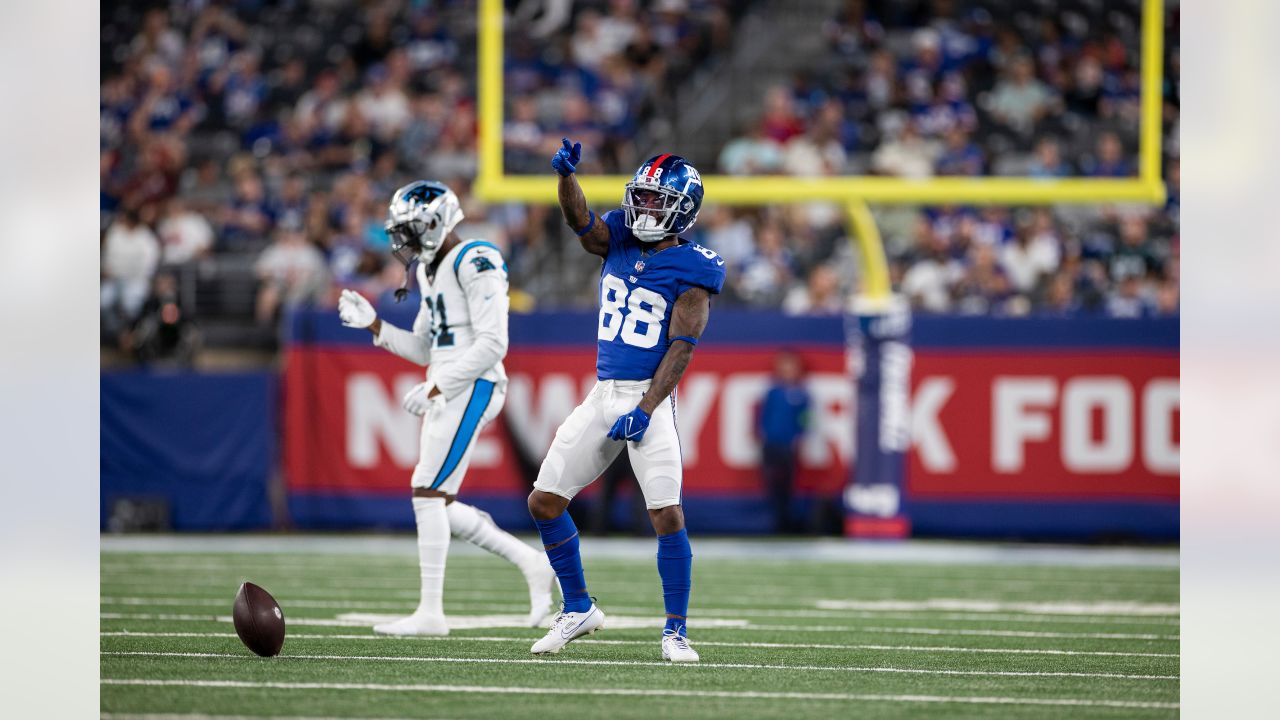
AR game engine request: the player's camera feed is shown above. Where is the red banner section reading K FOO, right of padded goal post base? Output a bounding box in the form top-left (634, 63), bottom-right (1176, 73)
top-left (908, 350), bottom-right (1179, 500)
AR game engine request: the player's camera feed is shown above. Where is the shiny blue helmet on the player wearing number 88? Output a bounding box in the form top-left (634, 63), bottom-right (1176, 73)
top-left (622, 154), bottom-right (703, 242)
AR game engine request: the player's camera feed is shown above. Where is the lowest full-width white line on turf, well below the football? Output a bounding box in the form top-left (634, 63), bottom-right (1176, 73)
top-left (101, 678), bottom-right (1179, 710)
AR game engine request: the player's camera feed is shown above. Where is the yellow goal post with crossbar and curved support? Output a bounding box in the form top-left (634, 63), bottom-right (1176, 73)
top-left (472, 0), bottom-right (1165, 306)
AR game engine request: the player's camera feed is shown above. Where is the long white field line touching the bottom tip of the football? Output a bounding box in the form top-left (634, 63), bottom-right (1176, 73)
top-left (101, 643), bottom-right (1179, 680)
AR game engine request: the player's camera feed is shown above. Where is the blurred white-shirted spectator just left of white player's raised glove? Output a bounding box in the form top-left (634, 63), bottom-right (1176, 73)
top-left (253, 228), bottom-right (329, 325)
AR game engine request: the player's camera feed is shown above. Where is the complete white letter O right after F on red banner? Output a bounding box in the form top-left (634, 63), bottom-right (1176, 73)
top-left (1061, 377), bottom-right (1133, 473)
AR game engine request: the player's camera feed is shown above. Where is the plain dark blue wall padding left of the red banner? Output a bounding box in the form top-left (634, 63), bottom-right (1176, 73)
top-left (100, 372), bottom-right (279, 530)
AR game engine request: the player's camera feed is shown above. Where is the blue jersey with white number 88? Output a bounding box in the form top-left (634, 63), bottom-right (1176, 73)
top-left (595, 210), bottom-right (724, 380)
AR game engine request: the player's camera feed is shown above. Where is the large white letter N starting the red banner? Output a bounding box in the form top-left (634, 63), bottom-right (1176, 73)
top-left (347, 373), bottom-right (421, 468)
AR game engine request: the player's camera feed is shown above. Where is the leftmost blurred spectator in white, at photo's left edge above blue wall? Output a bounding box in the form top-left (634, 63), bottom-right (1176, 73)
top-left (101, 205), bottom-right (160, 337)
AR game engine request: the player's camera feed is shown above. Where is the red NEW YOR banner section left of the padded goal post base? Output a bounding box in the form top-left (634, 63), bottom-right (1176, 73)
top-left (284, 346), bottom-right (854, 495)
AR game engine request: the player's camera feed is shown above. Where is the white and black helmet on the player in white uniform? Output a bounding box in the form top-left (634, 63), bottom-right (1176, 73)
top-left (385, 181), bottom-right (462, 266)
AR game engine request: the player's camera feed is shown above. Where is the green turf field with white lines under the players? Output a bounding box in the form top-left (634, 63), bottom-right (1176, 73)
top-left (101, 537), bottom-right (1179, 720)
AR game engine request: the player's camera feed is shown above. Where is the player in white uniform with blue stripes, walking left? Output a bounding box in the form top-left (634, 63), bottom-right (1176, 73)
top-left (338, 181), bottom-right (556, 635)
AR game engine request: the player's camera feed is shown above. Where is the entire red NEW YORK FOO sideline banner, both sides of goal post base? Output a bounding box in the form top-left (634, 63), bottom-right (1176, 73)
top-left (284, 346), bottom-right (1179, 501)
